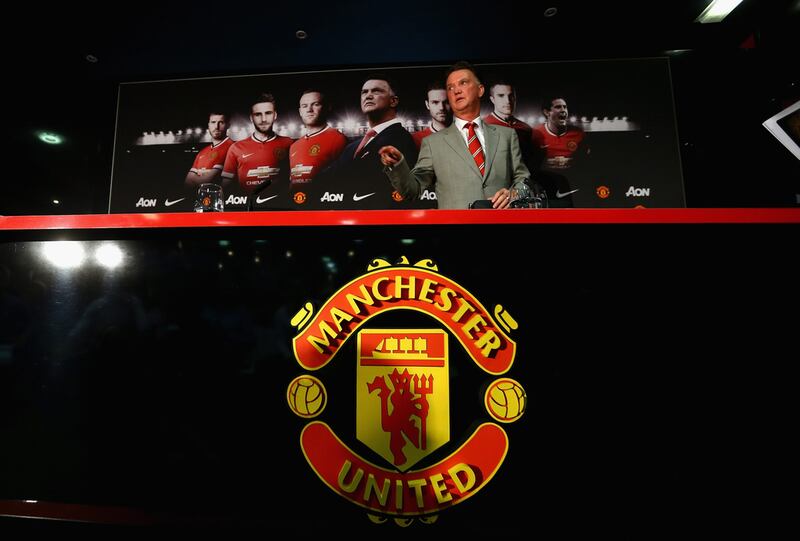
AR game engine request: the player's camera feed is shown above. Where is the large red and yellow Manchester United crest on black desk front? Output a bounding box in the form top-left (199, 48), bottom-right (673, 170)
top-left (287, 258), bottom-right (527, 526)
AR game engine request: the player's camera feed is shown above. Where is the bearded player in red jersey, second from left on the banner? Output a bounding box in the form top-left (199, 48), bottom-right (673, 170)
top-left (222, 94), bottom-right (293, 193)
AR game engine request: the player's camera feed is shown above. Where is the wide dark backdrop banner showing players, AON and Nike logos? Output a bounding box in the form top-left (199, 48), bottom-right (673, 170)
top-left (109, 58), bottom-right (685, 213)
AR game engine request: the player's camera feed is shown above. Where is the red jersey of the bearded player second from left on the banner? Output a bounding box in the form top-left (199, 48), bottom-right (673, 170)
top-left (222, 135), bottom-right (293, 191)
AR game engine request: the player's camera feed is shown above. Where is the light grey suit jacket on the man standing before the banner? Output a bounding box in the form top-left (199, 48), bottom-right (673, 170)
top-left (384, 122), bottom-right (530, 209)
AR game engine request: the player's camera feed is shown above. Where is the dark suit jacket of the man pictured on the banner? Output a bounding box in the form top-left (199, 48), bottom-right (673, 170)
top-left (312, 124), bottom-right (422, 209)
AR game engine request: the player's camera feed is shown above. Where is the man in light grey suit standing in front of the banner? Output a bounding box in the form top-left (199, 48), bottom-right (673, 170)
top-left (379, 62), bottom-right (530, 209)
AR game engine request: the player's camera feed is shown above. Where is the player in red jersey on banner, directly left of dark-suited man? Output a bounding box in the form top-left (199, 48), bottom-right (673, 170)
top-left (289, 89), bottom-right (347, 192)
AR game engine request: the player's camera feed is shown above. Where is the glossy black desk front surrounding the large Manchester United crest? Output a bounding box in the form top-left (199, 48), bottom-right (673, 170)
top-left (0, 220), bottom-right (798, 537)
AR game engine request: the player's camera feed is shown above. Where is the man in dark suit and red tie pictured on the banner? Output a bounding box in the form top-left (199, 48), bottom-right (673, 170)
top-left (315, 74), bottom-right (417, 209)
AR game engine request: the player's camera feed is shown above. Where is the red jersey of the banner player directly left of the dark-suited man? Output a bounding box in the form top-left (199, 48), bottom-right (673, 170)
top-left (289, 126), bottom-right (347, 188)
